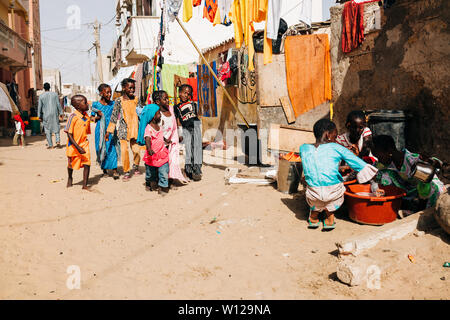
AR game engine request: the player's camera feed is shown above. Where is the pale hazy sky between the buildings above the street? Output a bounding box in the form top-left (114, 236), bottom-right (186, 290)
top-left (40, 0), bottom-right (116, 85)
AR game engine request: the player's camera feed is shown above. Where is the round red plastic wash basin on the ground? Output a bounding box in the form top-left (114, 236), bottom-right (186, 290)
top-left (345, 184), bottom-right (406, 226)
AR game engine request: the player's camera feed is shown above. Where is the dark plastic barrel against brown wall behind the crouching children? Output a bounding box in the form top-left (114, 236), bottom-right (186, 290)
top-left (368, 110), bottom-right (407, 150)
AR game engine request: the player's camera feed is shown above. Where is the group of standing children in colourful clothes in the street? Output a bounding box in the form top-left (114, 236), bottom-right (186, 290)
top-left (65, 79), bottom-right (203, 195)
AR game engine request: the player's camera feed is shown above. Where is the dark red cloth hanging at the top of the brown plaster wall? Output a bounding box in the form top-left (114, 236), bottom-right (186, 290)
top-left (342, 1), bottom-right (364, 53)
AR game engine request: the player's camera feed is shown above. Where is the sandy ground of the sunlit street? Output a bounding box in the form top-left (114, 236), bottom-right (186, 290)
top-left (0, 123), bottom-right (450, 299)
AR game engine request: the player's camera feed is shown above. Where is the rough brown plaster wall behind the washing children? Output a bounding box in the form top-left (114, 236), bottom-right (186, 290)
top-left (331, 0), bottom-right (450, 161)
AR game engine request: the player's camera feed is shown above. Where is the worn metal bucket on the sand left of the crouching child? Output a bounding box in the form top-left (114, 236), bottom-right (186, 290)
top-left (277, 159), bottom-right (302, 194)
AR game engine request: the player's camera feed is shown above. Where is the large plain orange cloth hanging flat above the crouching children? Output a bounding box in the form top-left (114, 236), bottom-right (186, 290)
top-left (285, 34), bottom-right (331, 117)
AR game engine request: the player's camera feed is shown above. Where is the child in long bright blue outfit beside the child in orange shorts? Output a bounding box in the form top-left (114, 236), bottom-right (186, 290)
top-left (92, 83), bottom-right (120, 180)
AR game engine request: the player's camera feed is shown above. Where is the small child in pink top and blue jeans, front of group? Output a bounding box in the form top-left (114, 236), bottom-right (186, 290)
top-left (143, 104), bottom-right (169, 195)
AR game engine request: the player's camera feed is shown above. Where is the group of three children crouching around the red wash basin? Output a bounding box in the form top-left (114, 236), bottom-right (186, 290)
top-left (300, 111), bottom-right (445, 231)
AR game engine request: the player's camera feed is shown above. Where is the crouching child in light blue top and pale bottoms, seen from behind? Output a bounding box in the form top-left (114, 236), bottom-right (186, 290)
top-left (300, 119), bottom-right (377, 230)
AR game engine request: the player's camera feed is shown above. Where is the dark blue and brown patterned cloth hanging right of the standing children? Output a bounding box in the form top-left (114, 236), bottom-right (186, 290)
top-left (197, 61), bottom-right (217, 117)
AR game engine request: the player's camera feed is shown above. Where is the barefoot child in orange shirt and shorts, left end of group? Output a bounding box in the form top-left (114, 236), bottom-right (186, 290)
top-left (64, 94), bottom-right (91, 190)
